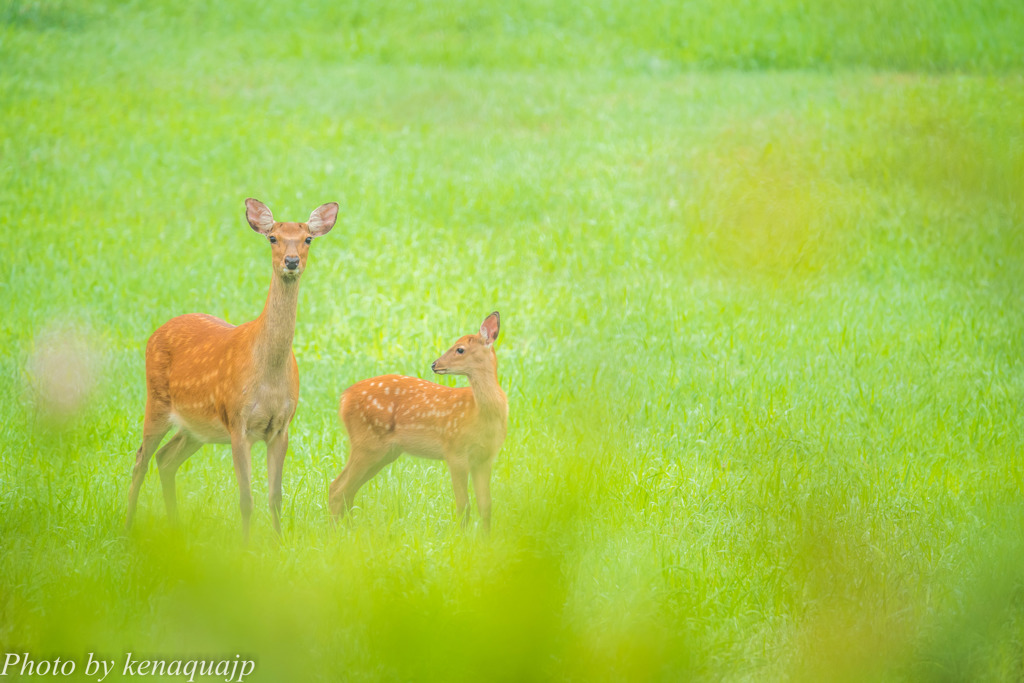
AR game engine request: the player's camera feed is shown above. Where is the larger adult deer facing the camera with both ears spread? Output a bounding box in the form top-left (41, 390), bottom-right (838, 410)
top-left (125, 199), bottom-right (338, 540)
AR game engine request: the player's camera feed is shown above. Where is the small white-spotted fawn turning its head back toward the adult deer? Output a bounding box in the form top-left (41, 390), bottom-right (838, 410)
top-left (329, 311), bottom-right (508, 529)
